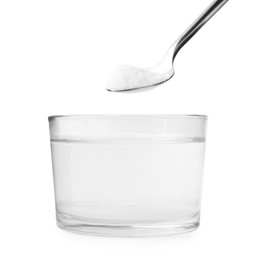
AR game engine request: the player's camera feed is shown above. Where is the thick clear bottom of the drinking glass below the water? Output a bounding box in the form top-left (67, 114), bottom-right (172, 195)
top-left (57, 212), bottom-right (199, 237)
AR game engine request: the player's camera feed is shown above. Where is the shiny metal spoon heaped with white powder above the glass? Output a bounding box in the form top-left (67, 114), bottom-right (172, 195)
top-left (107, 0), bottom-right (228, 92)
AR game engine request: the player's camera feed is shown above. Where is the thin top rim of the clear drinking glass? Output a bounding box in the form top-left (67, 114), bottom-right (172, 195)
top-left (48, 114), bottom-right (208, 121)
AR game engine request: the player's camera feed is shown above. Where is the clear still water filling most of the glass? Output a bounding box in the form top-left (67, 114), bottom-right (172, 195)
top-left (51, 139), bottom-right (205, 224)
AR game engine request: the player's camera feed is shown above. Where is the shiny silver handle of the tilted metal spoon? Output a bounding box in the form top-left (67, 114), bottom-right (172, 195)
top-left (172, 0), bottom-right (228, 59)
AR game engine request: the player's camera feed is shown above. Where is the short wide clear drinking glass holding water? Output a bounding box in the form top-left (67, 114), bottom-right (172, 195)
top-left (49, 115), bottom-right (207, 236)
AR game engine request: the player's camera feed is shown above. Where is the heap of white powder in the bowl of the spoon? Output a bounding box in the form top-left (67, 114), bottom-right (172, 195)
top-left (107, 65), bottom-right (165, 91)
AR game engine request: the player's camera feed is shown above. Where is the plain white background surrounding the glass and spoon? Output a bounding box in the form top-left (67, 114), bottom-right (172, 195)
top-left (0, 0), bottom-right (260, 260)
